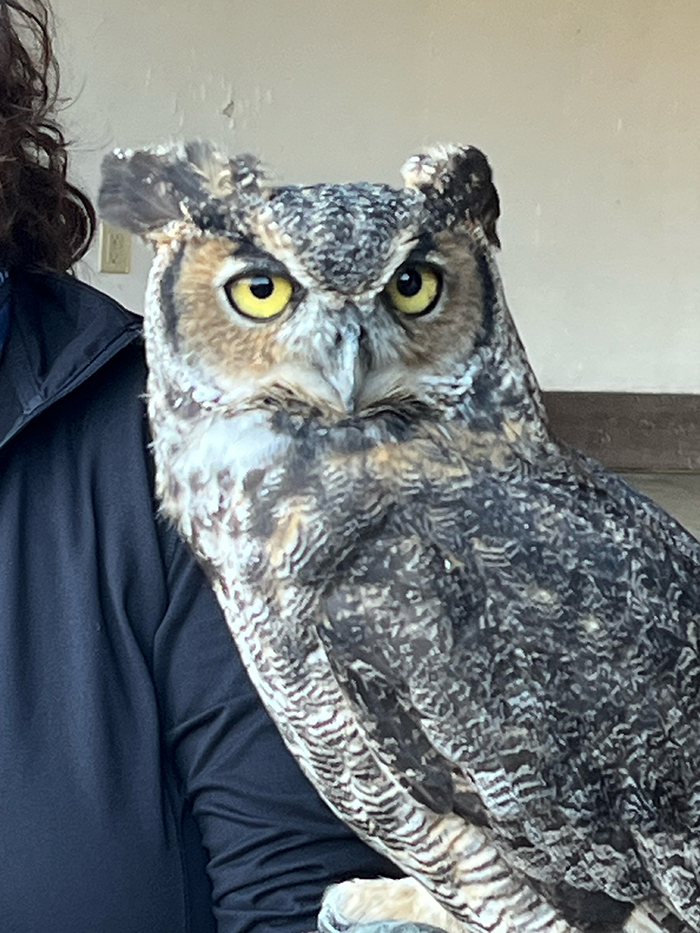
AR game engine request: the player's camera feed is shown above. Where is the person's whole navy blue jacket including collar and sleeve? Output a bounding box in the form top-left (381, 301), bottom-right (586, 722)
top-left (0, 274), bottom-right (394, 933)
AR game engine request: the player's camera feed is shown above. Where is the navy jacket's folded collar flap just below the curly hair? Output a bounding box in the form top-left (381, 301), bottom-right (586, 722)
top-left (0, 272), bottom-right (141, 448)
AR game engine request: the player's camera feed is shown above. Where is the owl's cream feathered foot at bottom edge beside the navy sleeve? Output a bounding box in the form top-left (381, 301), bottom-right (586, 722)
top-left (318, 878), bottom-right (468, 933)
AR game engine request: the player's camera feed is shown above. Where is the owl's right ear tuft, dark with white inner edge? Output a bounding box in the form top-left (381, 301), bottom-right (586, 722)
top-left (401, 146), bottom-right (501, 247)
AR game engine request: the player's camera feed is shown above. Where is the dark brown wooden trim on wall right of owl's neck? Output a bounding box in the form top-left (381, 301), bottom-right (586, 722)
top-left (544, 392), bottom-right (700, 472)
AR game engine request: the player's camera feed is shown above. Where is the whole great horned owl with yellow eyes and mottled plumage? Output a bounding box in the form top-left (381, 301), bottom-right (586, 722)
top-left (101, 144), bottom-right (700, 933)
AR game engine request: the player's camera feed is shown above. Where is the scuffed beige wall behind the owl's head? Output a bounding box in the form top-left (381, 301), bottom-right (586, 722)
top-left (54, 0), bottom-right (700, 392)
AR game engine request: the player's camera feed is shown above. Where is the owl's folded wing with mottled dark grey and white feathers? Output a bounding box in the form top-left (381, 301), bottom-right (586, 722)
top-left (323, 460), bottom-right (700, 924)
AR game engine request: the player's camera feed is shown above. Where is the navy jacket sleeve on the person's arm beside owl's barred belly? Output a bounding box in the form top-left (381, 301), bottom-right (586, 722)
top-left (154, 533), bottom-right (397, 933)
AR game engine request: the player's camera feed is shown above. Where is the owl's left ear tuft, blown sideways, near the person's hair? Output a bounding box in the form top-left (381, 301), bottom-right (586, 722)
top-left (98, 141), bottom-right (267, 239)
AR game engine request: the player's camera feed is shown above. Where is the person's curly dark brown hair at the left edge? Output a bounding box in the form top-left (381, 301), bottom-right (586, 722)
top-left (0, 0), bottom-right (95, 271)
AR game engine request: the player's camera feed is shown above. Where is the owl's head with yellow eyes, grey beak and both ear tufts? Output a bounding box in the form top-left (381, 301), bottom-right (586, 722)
top-left (99, 143), bottom-right (536, 434)
